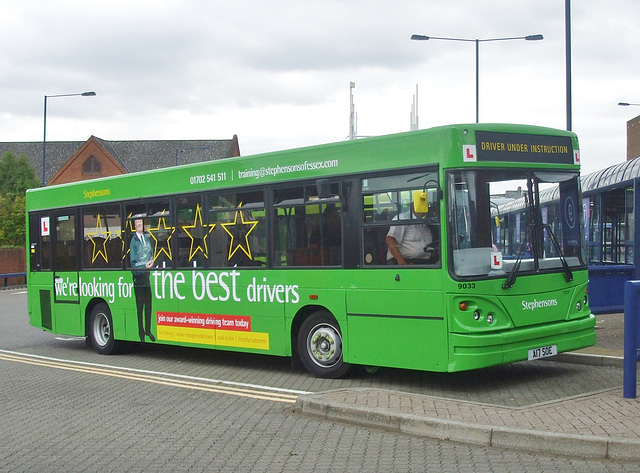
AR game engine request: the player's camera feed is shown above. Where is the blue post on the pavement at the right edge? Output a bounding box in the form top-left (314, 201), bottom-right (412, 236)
top-left (622, 281), bottom-right (640, 399)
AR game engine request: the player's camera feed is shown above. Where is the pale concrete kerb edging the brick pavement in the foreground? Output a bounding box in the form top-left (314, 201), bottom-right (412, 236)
top-left (294, 393), bottom-right (640, 461)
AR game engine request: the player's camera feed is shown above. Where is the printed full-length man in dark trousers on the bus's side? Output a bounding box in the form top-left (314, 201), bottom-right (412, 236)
top-left (129, 218), bottom-right (156, 342)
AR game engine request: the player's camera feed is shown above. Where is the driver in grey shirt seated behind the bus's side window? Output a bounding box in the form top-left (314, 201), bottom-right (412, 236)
top-left (384, 204), bottom-right (434, 265)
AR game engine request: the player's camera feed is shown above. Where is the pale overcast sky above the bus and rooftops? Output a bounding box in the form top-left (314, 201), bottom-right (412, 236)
top-left (0, 0), bottom-right (640, 173)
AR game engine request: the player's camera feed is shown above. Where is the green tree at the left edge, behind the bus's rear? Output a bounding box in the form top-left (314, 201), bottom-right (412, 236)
top-left (0, 151), bottom-right (40, 246)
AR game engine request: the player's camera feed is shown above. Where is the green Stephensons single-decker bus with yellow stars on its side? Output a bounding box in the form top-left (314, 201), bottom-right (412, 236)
top-left (27, 124), bottom-right (595, 378)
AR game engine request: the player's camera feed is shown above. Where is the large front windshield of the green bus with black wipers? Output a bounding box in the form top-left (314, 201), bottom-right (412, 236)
top-left (447, 169), bottom-right (585, 282)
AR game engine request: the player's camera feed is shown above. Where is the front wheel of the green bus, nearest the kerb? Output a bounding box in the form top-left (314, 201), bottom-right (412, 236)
top-left (298, 311), bottom-right (350, 379)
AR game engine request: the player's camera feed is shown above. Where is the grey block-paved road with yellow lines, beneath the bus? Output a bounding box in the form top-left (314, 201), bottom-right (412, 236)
top-left (0, 291), bottom-right (637, 472)
